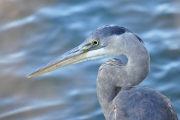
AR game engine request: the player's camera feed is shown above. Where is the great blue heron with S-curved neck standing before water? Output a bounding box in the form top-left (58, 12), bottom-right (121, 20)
top-left (27, 25), bottom-right (178, 120)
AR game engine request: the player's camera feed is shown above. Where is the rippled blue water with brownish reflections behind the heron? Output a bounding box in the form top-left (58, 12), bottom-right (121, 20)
top-left (0, 0), bottom-right (180, 120)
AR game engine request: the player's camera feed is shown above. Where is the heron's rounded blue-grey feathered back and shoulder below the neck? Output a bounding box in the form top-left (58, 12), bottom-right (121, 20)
top-left (109, 87), bottom-right (178, 120)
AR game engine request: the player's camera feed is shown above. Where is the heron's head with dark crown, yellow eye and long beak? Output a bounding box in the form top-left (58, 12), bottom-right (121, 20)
top-left (27, 25), bottom-right (141, 78)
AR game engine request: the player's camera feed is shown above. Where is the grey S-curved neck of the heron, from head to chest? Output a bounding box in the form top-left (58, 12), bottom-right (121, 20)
top-left (97, 41), bottom-right (150, 119)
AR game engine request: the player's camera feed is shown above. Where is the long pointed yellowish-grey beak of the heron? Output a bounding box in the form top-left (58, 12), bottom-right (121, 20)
top-left (27, 45), bottom-right (91, 78)
